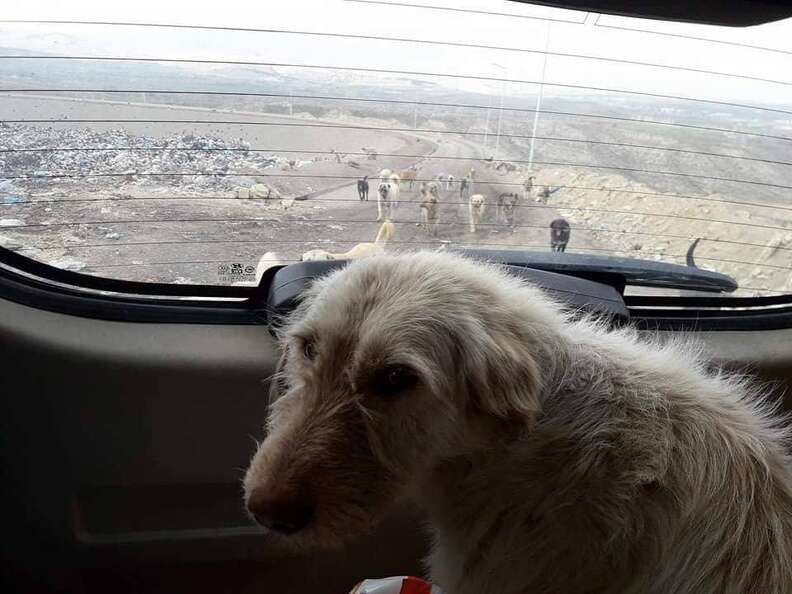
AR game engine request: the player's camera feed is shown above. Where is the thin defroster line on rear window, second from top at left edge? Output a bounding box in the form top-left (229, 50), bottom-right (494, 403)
top-left (0, 55), bottom-right (792, 115)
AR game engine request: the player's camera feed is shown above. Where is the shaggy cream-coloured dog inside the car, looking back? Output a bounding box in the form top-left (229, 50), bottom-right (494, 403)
top-left (244, 253), bottom-right (792, 594)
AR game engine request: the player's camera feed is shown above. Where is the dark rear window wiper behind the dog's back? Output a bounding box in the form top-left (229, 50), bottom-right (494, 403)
top-left (452, 248), bottom-right (738, 293)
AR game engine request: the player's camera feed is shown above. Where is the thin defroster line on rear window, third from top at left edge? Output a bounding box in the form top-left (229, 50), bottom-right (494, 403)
top-left (0, 89), bottom-right (792, 142)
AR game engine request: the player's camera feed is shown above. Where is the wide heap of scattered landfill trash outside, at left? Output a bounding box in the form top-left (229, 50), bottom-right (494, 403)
top-left (0, 122), bottom-right (294, 193)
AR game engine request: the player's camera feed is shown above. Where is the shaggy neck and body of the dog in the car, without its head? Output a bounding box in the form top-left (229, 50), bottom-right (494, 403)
top-left (417, 310), bottom-right (792, 594)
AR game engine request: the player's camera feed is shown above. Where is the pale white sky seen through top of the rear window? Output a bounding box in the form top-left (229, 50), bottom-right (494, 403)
top-left (0, 0), bottom-right (792, 105)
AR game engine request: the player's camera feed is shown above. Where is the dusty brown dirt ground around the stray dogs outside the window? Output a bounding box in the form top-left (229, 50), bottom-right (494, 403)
top-left (0, 97), bottom-right (792, 295)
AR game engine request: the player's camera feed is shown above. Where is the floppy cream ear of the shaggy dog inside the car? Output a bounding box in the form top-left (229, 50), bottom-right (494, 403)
top-left (463, 329), bottom-right (541, 421)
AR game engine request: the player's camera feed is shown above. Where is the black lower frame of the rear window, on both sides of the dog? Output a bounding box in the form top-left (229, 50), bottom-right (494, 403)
top-left (0, 247), bottom-right (792, 331)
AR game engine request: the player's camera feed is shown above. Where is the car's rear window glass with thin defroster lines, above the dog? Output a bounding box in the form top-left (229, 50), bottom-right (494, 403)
top-left (0, 0), bottom-right (792, 296)
